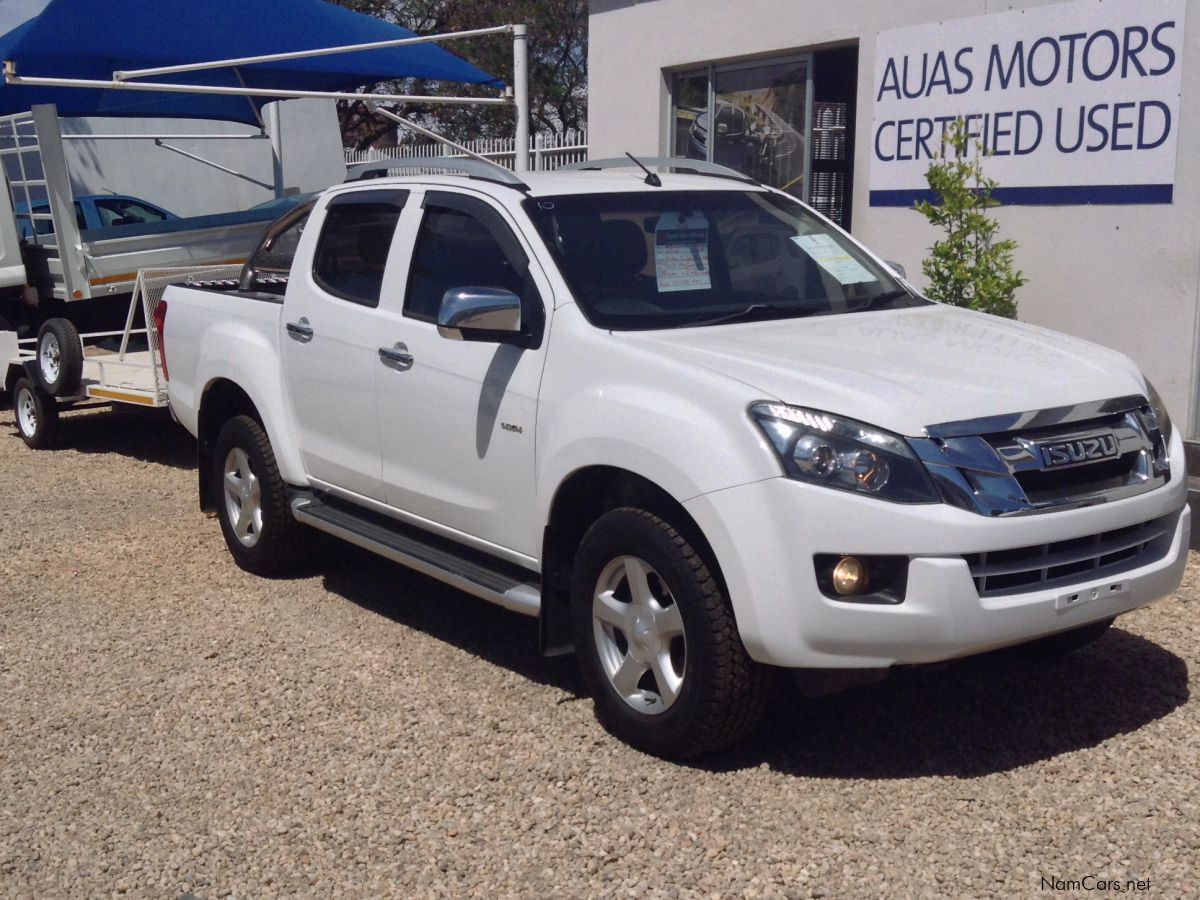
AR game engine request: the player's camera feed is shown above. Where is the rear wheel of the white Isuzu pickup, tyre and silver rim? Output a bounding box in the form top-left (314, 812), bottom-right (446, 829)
top-left (212, 415), bottom-right (307, 576)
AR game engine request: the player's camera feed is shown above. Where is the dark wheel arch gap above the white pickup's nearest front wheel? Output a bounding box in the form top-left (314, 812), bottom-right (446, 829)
top-left (539, 466), bottom-right (727, 656)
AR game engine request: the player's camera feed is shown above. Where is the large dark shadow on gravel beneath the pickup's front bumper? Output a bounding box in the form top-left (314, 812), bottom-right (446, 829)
top-left (697, 629), bottom-right (1188, 779)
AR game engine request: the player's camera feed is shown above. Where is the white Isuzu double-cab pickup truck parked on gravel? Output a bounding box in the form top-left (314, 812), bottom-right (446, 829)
top-left (155, 160), bottom-right (1189, 757)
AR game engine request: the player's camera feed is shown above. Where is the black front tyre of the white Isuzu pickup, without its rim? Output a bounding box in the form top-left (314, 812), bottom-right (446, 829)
top-left (571, 508), bottom-right (773, 758)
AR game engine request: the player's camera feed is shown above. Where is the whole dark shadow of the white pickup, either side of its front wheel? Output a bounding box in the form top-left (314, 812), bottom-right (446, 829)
top-left (317, 539), bottom-right (1188, 779)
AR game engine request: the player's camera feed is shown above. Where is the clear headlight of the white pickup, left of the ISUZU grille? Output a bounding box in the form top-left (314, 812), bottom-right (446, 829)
top-left (750, 403), bottom-right (938, 503)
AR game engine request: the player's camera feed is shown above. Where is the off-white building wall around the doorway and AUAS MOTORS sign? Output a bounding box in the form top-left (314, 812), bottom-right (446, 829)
top-left (588, 0), bottom-right (1200, 434)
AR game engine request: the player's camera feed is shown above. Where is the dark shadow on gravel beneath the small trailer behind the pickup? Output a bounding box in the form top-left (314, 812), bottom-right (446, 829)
top-left (5, 406), bottom-right (196, 469)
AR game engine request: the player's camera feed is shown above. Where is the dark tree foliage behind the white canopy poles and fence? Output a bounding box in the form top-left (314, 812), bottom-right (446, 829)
top-left (334, 0), bottom-right (588, 148)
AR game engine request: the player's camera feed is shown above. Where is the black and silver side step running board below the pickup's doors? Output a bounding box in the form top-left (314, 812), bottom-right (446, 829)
top-left (292, 494), bottom-right (541, 616)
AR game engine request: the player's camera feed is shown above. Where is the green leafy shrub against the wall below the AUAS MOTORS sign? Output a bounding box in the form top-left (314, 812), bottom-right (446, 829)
top-left (916, 120), bottom-right (1027, 319)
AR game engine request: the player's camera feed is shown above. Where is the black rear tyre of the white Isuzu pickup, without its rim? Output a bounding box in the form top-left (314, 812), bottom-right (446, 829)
top-left (211, 415), bottom-right (310, 577)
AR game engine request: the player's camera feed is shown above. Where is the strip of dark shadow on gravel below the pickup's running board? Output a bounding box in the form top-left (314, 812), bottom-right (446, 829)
top-left (317, 538), bottom-right (586, 698)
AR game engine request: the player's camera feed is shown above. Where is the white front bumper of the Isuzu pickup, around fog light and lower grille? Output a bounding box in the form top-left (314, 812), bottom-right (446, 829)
top-left (684, 446), bottom-right (1190, 668)
